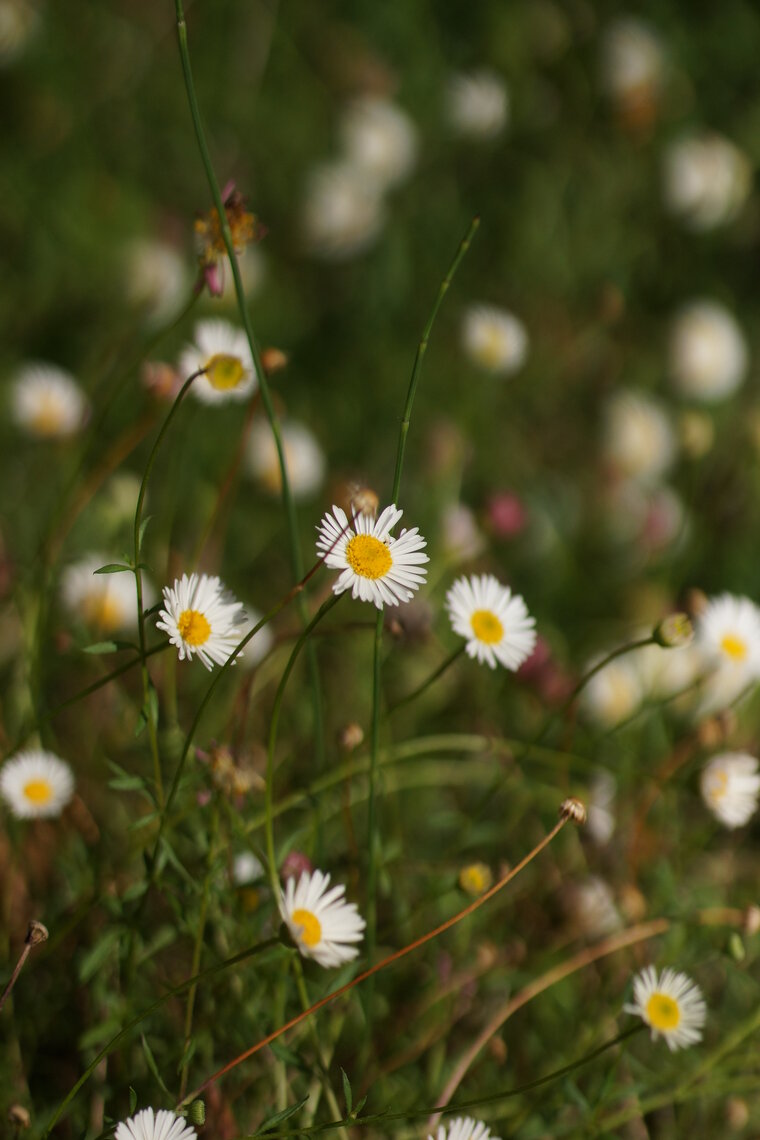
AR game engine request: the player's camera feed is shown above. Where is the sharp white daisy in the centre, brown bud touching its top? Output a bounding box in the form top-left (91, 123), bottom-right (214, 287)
top-left (317, 505), bottom-right (430, 610)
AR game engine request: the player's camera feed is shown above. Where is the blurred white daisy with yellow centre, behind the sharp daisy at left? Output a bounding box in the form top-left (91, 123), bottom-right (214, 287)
top-left (60, 554), bottom-right (153, 634)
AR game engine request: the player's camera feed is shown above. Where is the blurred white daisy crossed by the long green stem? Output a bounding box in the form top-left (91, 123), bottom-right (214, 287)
top-left (245, 420), bottom-right (326, 499)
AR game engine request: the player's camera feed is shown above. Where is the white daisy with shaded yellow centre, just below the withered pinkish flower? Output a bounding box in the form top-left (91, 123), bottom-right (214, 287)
top-left (179, 319), bottom-right (258, 404)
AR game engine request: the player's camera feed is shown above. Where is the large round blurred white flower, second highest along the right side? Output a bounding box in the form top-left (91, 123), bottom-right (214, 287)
top-left (663, 133), bottom-right (752, 230)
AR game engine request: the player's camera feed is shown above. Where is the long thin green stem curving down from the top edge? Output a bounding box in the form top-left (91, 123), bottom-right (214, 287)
top-left (174, 0), bottom-right (325, 767)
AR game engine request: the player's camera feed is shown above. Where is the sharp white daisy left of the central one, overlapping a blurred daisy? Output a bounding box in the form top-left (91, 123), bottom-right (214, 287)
top-left (156, 573), bottom-right (245, 669)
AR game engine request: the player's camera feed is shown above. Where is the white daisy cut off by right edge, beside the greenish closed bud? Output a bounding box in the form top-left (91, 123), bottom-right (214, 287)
top-left (696, 594), bottom-right (760, 703)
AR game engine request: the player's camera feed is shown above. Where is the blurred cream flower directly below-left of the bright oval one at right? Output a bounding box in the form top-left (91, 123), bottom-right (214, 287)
top-left (603, 389), bottom-right (676, 482)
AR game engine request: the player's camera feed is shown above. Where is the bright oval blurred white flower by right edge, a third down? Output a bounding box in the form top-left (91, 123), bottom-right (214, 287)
top-left (670, 300), bottom-right (749, 402)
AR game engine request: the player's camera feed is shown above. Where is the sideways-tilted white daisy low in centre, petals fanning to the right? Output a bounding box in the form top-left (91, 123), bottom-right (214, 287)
top-left (279, 871), bottom-right (366, 968)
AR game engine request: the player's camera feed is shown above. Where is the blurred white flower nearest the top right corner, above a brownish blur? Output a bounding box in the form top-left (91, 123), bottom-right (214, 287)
top-left (600, 16), bottom-right (665, 103)
